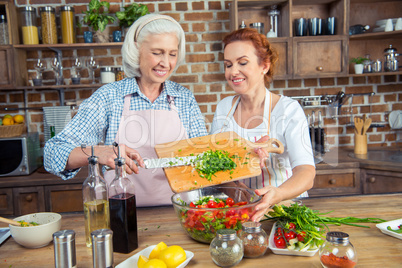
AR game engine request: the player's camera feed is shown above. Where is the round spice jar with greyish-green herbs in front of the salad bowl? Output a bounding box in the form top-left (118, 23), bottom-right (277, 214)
top-left (209, 229), bottom-right (243, 267)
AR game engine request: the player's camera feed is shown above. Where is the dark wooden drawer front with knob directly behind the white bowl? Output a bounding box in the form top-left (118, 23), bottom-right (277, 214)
top-left (13, 186), bottom-right (45, 216)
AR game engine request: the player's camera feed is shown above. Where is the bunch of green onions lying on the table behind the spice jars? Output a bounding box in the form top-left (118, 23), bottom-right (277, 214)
top-left (261, 203), bottom-right (385, 251)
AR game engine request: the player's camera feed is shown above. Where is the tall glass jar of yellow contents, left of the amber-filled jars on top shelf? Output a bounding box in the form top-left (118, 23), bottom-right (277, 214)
top-left (18, 6), bottom-right (39, 45)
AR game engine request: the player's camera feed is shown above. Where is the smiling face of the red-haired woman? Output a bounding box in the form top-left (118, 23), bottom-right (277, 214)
top-left (224, 41), bottom-right (269, 94)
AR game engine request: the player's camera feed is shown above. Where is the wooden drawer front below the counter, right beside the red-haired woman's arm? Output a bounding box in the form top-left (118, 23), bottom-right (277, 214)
top-left (308, 169), bottom-right (361, 197)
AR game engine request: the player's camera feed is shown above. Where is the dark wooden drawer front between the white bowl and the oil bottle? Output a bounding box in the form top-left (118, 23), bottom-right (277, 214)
top-left (45, 184), bottom-right (83, 212)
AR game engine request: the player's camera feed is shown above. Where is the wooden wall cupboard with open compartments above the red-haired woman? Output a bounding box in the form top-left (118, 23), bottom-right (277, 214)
top-left (229, 0), bottom-right (402, 79)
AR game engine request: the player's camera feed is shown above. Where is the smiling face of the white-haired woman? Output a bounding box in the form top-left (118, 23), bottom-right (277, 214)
top-left (140, 33), bottom-right (179, 84)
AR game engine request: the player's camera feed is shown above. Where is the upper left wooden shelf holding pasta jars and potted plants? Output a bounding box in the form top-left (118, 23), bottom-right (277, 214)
top-left (14, 42), bottom-right (123, 50)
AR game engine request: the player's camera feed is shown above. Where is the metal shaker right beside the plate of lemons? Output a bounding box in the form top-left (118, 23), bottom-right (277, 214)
top-left (91, 229), bottom-right (113, 268)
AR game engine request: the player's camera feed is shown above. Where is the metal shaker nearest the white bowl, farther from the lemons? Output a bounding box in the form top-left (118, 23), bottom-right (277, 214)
top-left (53, 230), bottom-right (77, 268)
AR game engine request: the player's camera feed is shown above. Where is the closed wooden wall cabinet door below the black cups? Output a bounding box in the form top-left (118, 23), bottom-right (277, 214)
top-left (293, 36), bottom-right (347, 78)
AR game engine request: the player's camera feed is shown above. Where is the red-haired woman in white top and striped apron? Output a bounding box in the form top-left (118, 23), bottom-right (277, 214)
top-left (211, 28), bottom-right (315, 221)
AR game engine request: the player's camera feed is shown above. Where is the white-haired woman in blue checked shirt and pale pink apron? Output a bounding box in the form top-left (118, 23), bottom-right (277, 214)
top-left (44, 14), bottom-right (207, 206)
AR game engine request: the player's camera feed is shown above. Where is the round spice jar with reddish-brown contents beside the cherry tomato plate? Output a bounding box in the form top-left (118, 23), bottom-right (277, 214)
top-left (239, 221), bottom-right (268, 258)
